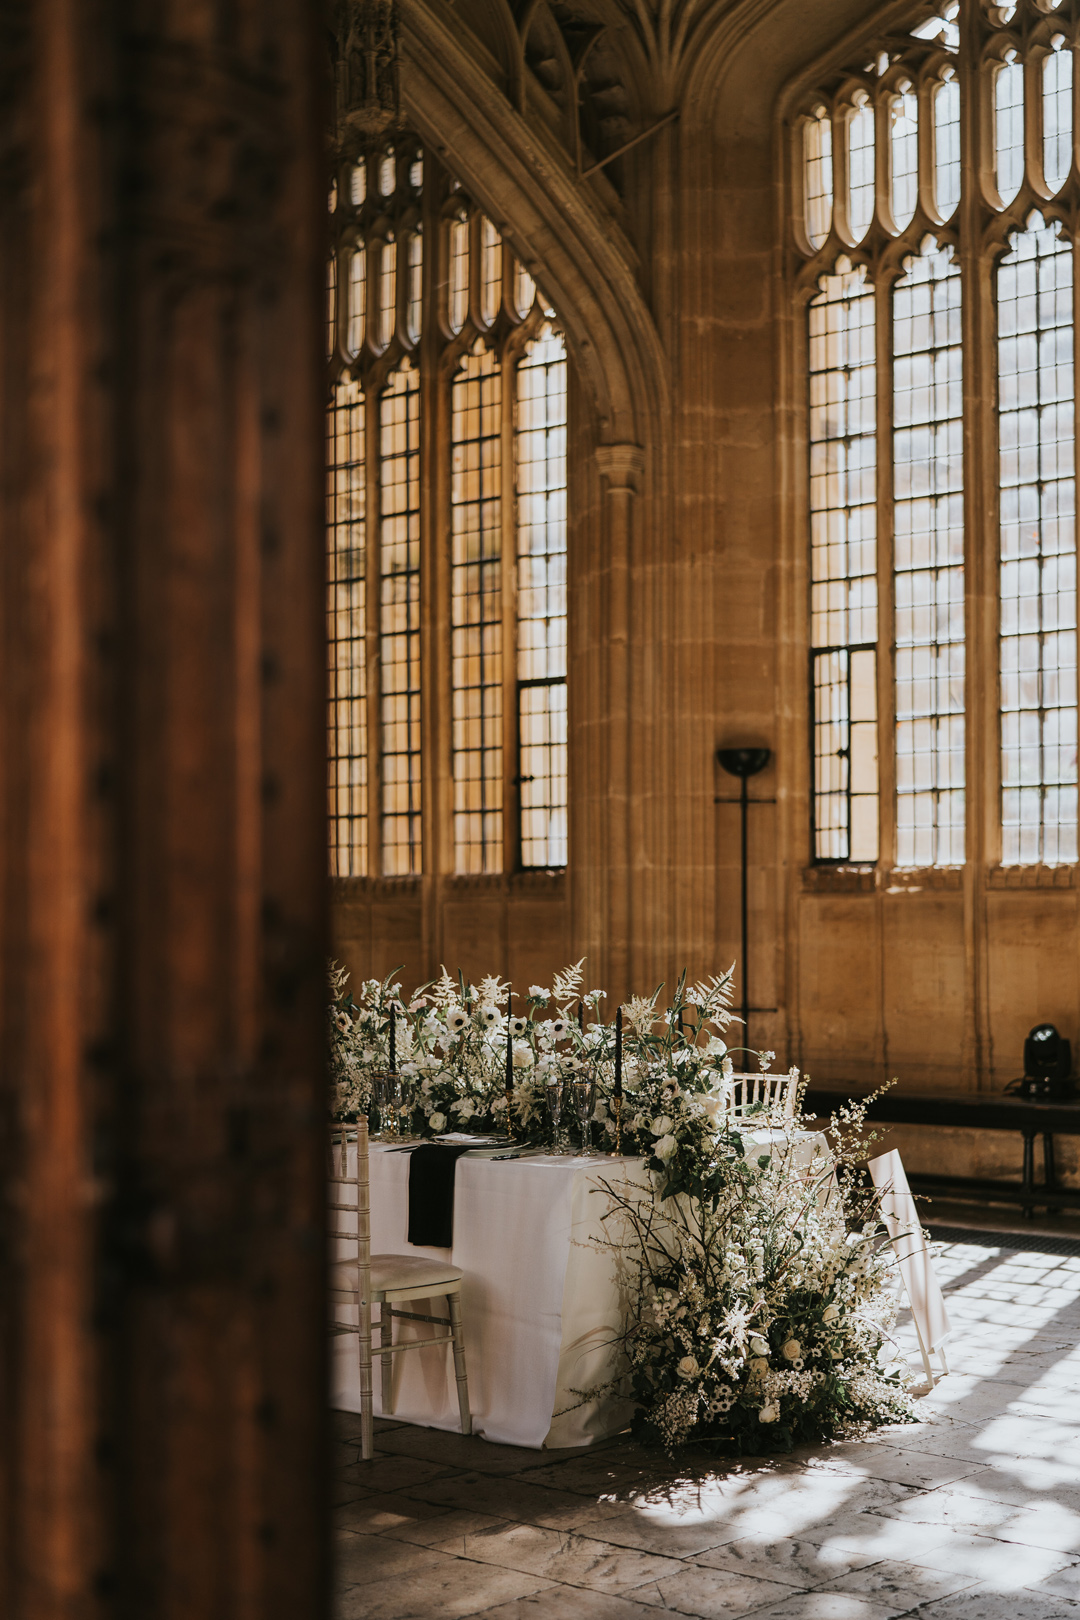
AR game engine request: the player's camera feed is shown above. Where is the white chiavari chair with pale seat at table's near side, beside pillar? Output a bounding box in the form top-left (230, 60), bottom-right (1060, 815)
top-left (329, 1115), bottom-right (473, 1460)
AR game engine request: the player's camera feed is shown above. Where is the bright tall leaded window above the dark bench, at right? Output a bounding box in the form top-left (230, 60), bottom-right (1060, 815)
top-left (789, 0), bottom-right (1080, 868)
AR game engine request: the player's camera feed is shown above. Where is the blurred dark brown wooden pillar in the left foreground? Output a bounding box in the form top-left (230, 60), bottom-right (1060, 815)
top-left (0, 0), bottom-right (325, 1620)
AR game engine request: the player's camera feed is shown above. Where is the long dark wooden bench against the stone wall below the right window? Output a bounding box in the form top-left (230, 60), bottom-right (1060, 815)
top-left (803, 1081), bottom-right (1080, 1220)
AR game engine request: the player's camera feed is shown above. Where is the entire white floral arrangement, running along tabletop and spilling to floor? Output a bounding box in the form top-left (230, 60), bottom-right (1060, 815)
top-left (330, 962), bottom-right (912, 1452)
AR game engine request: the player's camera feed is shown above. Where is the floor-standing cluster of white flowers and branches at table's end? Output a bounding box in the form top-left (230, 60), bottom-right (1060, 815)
top-left (588, 1121), bottom-right (913, 1453)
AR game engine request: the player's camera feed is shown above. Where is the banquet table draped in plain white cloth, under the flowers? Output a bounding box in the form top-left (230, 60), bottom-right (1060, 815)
top-left (332, 1129), bottom-right (826, 1448)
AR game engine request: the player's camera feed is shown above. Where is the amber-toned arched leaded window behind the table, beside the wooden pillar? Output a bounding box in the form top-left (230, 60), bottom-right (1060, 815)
top-left (327, 138), bottom-right (567, 876)
